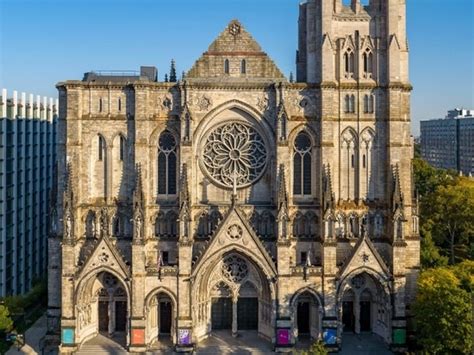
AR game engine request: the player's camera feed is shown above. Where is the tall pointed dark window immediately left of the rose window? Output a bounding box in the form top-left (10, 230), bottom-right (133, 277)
top-left (158, 131), bottom-right (177, 195)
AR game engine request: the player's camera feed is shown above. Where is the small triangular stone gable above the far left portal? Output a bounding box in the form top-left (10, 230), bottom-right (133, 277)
top-left (78, 238), bottom-right (130, 279)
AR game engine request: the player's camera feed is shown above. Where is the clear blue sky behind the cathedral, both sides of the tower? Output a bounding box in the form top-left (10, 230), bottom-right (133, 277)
top-left (0, 0), bottom-right (474, 135)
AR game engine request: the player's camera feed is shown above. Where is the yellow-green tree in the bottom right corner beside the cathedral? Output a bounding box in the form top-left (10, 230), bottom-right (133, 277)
top-left (413, 263), bottom-right (474, 354)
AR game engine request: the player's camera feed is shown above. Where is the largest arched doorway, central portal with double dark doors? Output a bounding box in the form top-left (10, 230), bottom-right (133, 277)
top-left (193, 252), bottom-right (274, 339)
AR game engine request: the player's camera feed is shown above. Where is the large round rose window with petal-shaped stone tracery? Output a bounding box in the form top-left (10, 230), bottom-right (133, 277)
top-left (202, 122), bottom-right (267, 188)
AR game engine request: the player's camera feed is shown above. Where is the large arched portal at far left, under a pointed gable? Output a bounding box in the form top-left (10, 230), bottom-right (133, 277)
top-left (76, 271), bottom-right (129, 346)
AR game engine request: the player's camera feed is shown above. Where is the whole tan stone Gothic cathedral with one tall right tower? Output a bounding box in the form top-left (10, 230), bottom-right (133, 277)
top-left (48, 0), bottom-right (420, 353)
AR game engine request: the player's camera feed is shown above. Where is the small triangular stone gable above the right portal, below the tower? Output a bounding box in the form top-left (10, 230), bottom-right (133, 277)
top-left (339, 235), bottom-right (390, 279)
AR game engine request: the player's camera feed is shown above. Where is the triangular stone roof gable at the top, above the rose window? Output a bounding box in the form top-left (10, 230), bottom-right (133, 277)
top-left (186, 20), bottom-right (286, 81)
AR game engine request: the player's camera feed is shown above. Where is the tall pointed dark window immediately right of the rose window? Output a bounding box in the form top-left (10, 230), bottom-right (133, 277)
top-left (293, 132), bottom-right (312, 195)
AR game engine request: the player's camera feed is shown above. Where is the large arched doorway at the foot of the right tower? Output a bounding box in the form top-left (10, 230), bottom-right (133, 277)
top-left (339, 272), bottom-right (391, 342)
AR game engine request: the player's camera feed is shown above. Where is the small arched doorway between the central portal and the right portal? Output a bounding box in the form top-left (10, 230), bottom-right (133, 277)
top-left (292, 290), bottom-right (322, 341)
